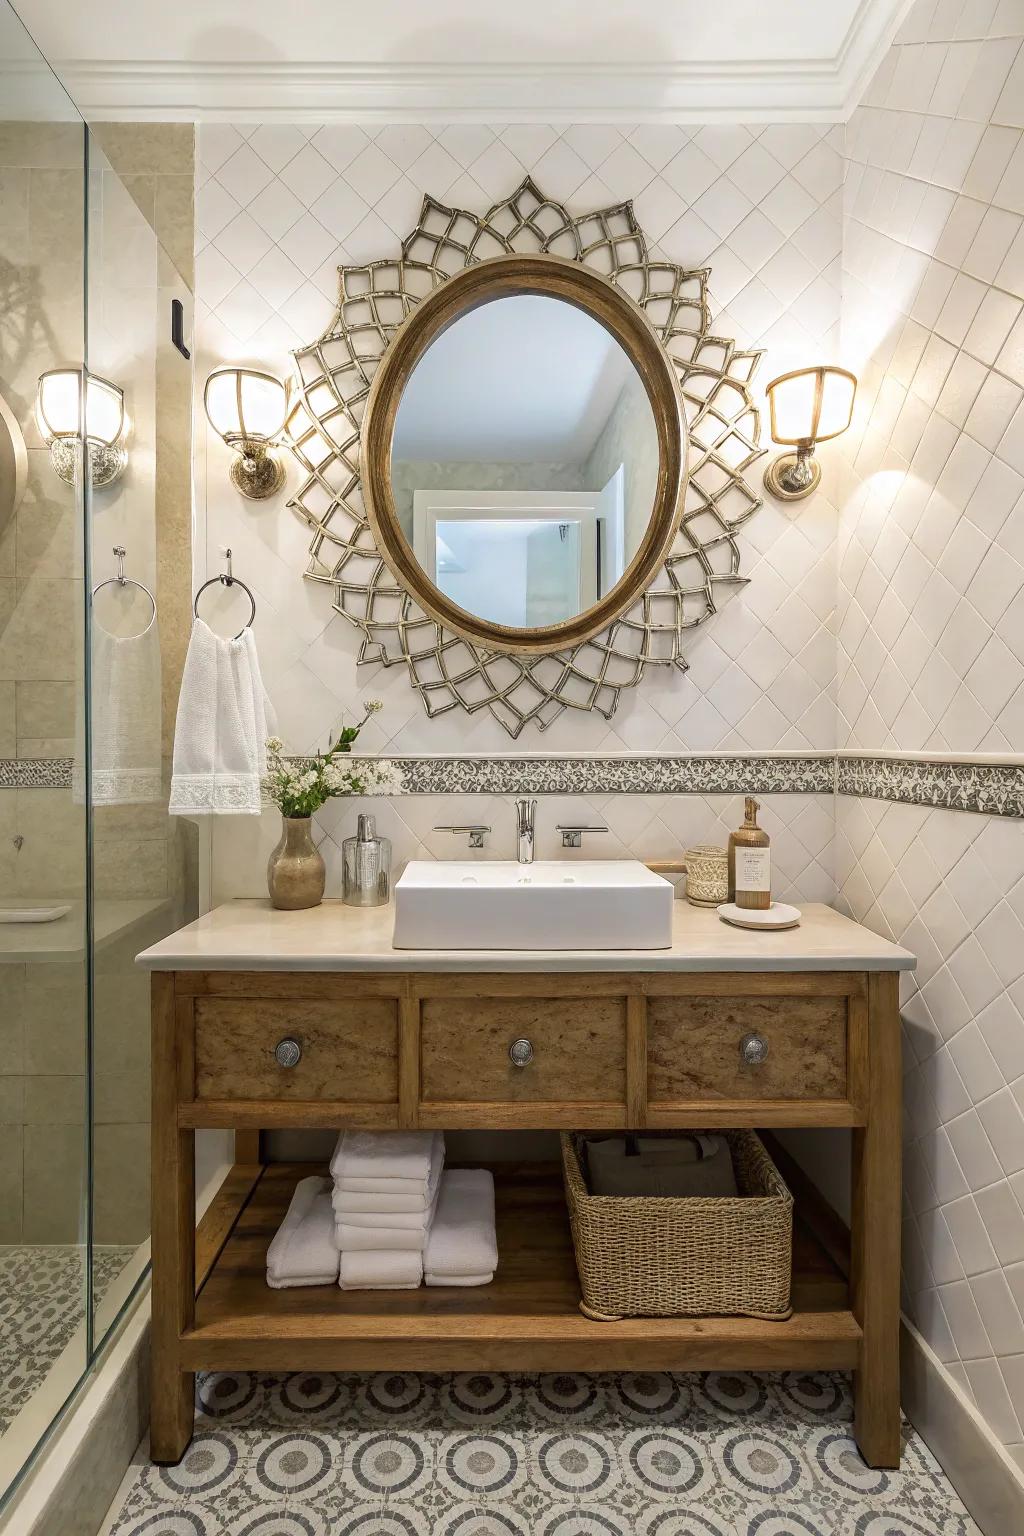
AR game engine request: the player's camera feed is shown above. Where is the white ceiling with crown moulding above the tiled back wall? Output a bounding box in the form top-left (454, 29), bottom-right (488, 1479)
top-left (5, 0), bottom-right (906, 120)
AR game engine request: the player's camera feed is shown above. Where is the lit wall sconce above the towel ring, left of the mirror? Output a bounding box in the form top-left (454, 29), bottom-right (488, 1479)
top-left (203, 367), bottom-right (289, 501)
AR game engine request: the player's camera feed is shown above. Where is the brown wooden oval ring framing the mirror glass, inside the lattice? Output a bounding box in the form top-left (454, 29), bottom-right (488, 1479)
top-left (362, 253), bottom-right (686, 656)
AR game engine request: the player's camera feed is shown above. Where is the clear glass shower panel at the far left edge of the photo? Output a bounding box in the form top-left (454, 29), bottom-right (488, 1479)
top-left (0, 0), bottom-right (89, 1499)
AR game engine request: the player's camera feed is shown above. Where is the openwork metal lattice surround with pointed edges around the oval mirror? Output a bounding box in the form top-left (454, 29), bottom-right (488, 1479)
top-left (287, 177), bottom-right (763, 739)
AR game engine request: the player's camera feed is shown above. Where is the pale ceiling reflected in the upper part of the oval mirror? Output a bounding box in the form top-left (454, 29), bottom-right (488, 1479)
top-left (393, 293), bottom-right (631, 464)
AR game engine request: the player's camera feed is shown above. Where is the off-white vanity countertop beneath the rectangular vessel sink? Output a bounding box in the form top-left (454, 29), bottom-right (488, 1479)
top-left (138, 899), bottom-right (917, 971)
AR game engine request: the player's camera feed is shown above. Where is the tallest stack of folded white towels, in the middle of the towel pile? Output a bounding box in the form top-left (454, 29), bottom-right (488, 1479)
top-left (330, 1130), bottom-right (444, 1290)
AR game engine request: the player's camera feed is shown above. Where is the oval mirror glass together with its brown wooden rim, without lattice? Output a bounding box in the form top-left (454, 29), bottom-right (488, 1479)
top-left (364, 255), bottom-right (685, 651)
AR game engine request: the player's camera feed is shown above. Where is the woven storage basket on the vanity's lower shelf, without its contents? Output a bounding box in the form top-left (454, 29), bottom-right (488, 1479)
top-left (562, 1130), bottom-right (792, 1321)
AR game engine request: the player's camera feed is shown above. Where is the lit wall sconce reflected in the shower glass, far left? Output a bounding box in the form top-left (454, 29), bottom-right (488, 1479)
top-left (35, 369), bottom-right (127, 490)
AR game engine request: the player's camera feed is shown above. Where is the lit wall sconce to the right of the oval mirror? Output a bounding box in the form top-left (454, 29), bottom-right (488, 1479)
top-left (765, 366), bottom-right (857, 501)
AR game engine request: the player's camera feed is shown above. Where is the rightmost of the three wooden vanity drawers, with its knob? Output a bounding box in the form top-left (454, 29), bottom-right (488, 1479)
top-left (648, 997), bottom-right (847, 1103)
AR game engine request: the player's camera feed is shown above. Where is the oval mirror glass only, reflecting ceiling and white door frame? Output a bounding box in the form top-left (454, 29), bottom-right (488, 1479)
top-left (391, 293), bottom-right (659, 630)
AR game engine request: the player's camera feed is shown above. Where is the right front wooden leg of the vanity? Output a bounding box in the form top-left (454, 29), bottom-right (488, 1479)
top-left (851, 972), bottom-right (903, 1467)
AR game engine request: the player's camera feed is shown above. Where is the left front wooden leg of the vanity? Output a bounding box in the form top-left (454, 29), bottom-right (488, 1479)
top-left (149, 972), bottom-right (195, 1465)
